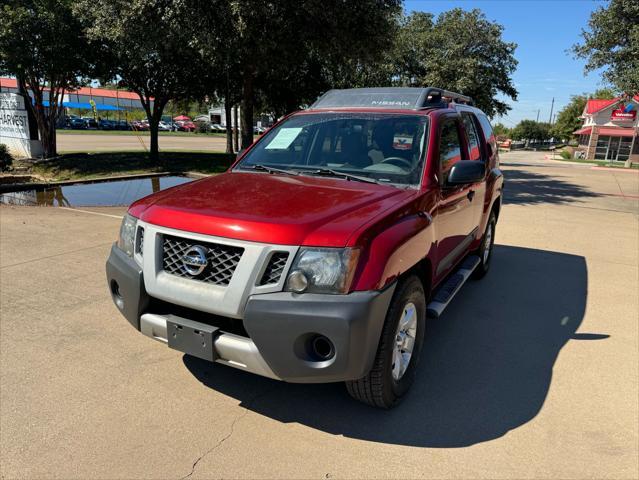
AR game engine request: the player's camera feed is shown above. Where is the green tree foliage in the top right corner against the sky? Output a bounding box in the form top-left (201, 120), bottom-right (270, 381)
top-left (572, 0), bottom-right (639, 94)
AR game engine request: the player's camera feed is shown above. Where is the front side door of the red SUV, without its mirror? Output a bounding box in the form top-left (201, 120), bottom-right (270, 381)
top-left (433, 115), bottom-right (476, 281)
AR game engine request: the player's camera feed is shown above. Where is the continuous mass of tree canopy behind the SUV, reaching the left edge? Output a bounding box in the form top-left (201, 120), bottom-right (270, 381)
top-left (0, 0), bottom-right (517, 158)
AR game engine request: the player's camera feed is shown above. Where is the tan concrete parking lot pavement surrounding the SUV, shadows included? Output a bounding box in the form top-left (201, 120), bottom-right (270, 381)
top-left (0, 153), bottom-right (639, 479)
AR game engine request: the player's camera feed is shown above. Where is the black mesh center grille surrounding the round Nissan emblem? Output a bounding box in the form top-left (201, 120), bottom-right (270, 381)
top-left (162, 235), bottom-right (244, 286)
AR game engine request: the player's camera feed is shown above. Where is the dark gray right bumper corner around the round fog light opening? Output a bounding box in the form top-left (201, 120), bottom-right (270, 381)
top-left (244, 284), bottom-right (395, 383)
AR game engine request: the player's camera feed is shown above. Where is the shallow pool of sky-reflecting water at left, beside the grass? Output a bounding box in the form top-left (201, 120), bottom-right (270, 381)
top-left (0, 176), bottom-right (193, 207)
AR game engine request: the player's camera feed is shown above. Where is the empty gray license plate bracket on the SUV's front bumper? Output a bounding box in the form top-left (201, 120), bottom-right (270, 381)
top-left (166, 315), bottom-right (218, 362)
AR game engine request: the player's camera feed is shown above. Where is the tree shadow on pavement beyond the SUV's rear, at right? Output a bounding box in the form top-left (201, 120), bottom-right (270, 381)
top-left (504, 170), bottom-right (601, 205)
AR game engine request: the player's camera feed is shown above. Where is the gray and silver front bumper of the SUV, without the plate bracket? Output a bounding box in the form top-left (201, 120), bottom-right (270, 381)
top-left (106, 245), bottom-right (395, 383)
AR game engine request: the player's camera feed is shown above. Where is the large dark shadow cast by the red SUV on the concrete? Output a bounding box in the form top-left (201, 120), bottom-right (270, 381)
top-left (184, 245), bottom-right (596, 448)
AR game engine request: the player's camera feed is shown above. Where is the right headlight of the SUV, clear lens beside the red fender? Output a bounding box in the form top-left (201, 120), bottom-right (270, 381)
top-left (286, 247), bottom-right (359, 293)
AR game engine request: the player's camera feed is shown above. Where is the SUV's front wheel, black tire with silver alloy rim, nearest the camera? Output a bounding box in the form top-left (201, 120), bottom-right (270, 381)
top-left (346, 275), bottom-right (426, 408)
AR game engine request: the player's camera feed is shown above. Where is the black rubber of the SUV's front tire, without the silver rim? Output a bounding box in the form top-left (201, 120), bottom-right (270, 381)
top-left (346, 275), bottom-right (426, 409)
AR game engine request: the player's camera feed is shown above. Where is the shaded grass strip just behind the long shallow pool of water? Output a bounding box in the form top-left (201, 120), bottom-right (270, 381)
top-left (30, 152), bottom-right (235, 181)
